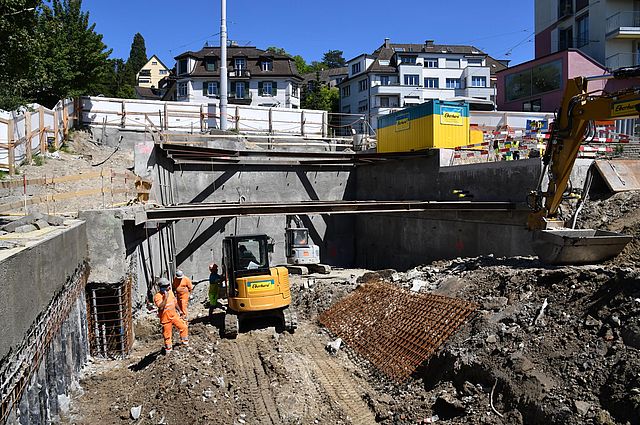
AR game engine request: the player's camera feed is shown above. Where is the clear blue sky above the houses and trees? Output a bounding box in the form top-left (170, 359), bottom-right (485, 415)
top-left (82, 0), bottom-right (534, 67)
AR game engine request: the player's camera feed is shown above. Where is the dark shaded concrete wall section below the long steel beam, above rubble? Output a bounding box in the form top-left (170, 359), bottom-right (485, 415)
top-left (356, 211), bottom-right (534, 270)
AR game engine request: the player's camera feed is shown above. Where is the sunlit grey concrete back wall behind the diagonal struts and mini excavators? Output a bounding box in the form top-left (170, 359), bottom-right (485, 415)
top-left (168, 161), bottom-right (355, 280)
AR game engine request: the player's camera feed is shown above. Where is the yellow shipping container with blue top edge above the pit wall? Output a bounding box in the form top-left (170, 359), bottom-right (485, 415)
top-left (377, 100), bottom-right (469, 152)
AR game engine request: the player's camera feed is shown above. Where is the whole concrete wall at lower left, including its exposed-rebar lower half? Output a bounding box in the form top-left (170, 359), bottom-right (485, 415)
top-left (0, 222), bottom-right (88, 424)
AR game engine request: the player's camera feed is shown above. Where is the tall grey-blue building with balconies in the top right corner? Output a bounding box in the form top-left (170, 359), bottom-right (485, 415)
top-left (535, 0), bottom-right (640, 69)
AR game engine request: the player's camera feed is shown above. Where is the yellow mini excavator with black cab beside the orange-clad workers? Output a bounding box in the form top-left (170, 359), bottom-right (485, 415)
top-left (222, 235), bottom-right (298, 338)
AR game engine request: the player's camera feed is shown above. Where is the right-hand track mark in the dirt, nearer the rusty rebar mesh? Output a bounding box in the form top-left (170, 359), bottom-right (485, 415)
top-left (302, 342), bottom-right (376, 425)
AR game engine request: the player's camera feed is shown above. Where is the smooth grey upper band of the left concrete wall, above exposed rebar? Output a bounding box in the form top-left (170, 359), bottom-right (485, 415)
top-left (0, 222), bottom-right (87, 360)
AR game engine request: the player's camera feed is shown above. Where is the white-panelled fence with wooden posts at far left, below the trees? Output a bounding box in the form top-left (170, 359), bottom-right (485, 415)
top-left (0, 99), bottom-right (76, 175)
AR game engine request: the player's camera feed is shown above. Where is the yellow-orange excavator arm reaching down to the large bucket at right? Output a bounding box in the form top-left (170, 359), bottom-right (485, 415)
top-left (527, 68), bottom-right (640, 230)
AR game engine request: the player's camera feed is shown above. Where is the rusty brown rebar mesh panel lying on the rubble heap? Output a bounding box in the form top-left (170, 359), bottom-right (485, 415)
top-left (319, 282), bottom-right (477, 382)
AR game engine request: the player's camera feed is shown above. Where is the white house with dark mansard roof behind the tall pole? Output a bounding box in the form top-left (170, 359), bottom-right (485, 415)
top-left (174, 45), bottom-right (302, 109)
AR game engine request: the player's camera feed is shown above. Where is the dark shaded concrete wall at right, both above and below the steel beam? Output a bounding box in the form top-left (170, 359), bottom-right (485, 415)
top-left (355, 153), bottom-right (591, 269)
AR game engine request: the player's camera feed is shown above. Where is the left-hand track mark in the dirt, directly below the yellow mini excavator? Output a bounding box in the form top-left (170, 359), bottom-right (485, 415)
top-left (231, 340), bottom-right (282, 425)
